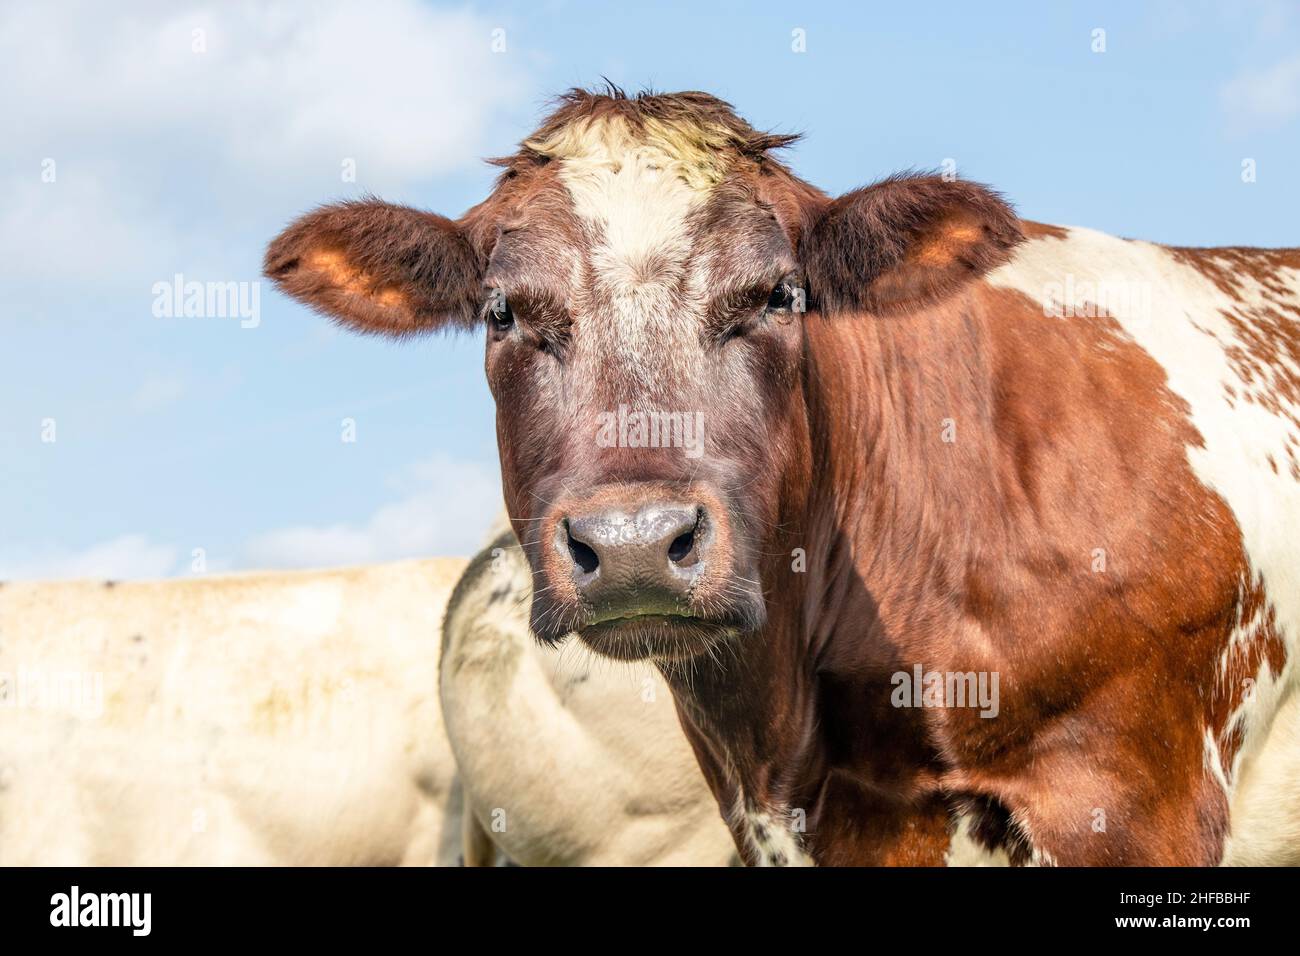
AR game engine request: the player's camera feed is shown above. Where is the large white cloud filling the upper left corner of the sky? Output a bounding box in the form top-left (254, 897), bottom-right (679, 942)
top-left (0, 0), bottom-right (520, 278)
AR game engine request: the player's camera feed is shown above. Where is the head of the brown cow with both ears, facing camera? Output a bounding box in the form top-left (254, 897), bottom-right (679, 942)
top-left (265, 91), bottom-right (1019, 659)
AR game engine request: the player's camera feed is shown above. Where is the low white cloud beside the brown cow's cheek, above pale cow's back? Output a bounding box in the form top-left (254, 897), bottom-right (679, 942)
top-left (243, 458), bottom-right (502, 568)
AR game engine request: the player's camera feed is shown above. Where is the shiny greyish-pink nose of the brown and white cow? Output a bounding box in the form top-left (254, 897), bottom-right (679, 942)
top-left (555, 502), bottom-right (712, 620)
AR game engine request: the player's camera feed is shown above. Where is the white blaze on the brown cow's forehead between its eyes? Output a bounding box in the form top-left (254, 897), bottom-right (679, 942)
top-left (530, 118), bottom-right (722, 401)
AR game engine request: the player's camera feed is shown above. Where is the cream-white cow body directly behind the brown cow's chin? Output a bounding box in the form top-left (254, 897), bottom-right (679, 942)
top-left (442, 522), bottom-right (736, 866)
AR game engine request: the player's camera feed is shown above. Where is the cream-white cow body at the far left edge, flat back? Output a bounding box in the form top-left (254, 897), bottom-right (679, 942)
top-left (0, 559), bottom-right (465, 865)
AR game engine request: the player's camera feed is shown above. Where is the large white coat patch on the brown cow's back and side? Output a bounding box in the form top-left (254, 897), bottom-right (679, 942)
top-left (989, 229), bottom-right (1300, 816)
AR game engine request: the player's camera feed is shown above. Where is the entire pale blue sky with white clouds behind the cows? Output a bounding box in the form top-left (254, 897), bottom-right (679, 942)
top-left (0, 0), bottom-right (1300, 578)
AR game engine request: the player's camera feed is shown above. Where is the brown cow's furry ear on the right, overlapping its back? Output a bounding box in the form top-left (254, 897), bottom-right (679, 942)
top-left (800, 176), bottom-right (1024, 315)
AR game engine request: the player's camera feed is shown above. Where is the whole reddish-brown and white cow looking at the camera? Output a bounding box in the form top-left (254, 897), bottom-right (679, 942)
top-left (267, 91), bottom-right (1300, 865)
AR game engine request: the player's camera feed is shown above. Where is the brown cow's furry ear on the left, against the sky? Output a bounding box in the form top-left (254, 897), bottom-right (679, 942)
top-left (263, 199), bottom-right (481, 337)
